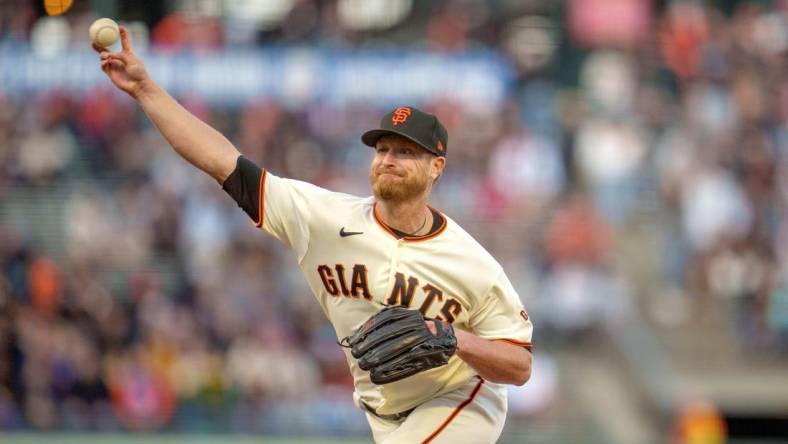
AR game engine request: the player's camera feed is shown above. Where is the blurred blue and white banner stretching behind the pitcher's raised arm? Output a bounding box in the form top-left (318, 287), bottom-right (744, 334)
top-left (0, 43), bottom-right (514, 107)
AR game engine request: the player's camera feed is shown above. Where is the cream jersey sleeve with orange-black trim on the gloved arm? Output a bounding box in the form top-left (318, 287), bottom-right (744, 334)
top-left (468, 270), bottom-right (533, 350)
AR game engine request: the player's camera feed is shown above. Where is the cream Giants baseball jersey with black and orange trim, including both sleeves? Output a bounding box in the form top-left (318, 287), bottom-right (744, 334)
top-left (257, 171), bottom-right (532, 414)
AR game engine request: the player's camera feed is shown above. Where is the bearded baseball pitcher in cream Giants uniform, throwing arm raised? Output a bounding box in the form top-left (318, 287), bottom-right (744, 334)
top-left (94, 28), bottom-right (532, 444)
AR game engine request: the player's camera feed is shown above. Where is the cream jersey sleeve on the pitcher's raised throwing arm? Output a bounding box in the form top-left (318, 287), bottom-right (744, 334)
top-left (257, 171), bottom-right (327, 262)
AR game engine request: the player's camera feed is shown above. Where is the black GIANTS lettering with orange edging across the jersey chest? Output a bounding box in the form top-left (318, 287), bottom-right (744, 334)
top-left (317, 264), bottom-right (462, 323)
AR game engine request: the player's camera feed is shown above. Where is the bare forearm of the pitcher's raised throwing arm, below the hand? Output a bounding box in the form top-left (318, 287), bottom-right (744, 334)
top-left (134, 80), bottom-right (241, 184)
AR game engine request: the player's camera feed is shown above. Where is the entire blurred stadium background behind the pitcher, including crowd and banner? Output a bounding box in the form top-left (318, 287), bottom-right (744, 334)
top-left (0, 0), bottom-right (788, 444)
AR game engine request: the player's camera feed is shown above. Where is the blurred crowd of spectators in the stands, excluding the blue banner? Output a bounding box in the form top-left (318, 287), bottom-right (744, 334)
top-left (0, 0), bottom-right (788, 434)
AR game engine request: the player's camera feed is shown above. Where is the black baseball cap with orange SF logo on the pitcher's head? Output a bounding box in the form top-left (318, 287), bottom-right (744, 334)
top-left (361, 106), bottom-right (449, 157)
